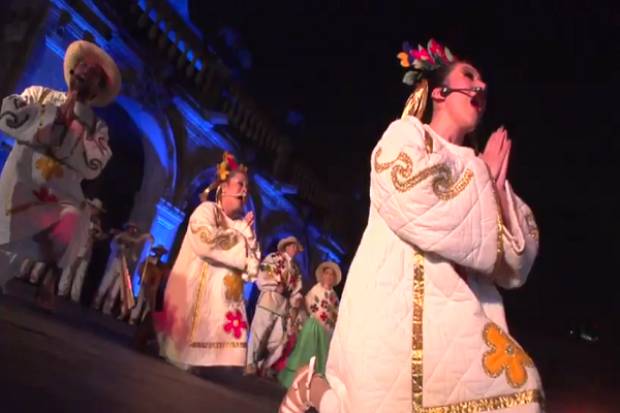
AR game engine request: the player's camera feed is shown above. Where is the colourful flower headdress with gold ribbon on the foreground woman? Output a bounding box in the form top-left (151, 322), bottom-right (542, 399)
top-left (396, 39), bottom-right (457, 119)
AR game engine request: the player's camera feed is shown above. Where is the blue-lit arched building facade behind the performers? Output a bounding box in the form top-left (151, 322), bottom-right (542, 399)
top-left (0, 0), bottom-right (344, 296)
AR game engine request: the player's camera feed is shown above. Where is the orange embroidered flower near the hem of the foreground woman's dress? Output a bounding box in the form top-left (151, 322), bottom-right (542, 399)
top-left (482, 323), bottom-right (534, 388)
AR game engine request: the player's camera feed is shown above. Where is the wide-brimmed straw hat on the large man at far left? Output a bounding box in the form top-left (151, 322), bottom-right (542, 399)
top-left (63, 40), bottom-right (121, 107)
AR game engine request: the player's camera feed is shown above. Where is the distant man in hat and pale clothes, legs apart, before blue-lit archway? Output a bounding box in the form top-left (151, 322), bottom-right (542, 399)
top-left (93, 222), bottom-right (154, 319)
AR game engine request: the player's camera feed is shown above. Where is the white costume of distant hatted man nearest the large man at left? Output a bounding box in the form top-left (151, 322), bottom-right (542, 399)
top-left (58, 217), bottom-right (106, 303)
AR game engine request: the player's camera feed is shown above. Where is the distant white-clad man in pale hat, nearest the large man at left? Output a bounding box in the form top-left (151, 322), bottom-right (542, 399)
top-left (58, 198), bottom-right (108, 303)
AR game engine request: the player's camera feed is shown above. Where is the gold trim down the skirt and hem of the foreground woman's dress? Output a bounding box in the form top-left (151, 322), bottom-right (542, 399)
top-left (411, 249), bottom-right (544, 413)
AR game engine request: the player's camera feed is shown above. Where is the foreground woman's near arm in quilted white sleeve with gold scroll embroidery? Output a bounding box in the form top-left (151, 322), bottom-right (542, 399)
top-left (370, 118), bottom-right (501, 274)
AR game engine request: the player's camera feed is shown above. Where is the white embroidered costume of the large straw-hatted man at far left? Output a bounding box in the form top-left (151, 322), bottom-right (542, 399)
top-left (0, 86), bottom-right (112, 268)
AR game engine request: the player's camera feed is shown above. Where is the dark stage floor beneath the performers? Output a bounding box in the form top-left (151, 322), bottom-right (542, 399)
top-left (0, 281), bottom-right (620, 413)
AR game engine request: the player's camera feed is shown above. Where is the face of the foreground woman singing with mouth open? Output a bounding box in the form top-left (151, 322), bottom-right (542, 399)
top-left (442, 63), bottom-right (486, 133)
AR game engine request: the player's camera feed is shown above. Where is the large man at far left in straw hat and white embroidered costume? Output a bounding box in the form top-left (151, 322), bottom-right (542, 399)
top-left (0, 41), bottom-right (121, 308)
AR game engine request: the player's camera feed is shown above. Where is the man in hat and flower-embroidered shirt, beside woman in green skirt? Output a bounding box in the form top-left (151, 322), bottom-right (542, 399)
top-left (245, 236), bottom-right (303, 376)
